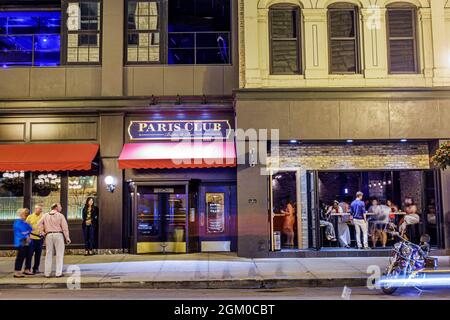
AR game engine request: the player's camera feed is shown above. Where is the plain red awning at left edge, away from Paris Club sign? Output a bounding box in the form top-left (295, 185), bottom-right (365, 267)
top-left (0, 144), bottom-right (99, 171)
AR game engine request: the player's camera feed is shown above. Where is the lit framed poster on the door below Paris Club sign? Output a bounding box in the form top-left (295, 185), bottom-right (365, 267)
top-left (206, 193), bottom-right (225, 233)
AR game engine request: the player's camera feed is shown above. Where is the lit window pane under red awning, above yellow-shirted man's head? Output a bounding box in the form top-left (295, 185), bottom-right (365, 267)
top-left (31, 173), bottom-right (61, 212)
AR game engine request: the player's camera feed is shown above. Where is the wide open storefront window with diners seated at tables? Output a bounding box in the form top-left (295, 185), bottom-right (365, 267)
top-left (316, 170), bottom-right (441, 248)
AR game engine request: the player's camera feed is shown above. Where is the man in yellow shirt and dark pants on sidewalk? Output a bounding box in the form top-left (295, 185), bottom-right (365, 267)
top-left (25, 204), bottom-right (44, 275)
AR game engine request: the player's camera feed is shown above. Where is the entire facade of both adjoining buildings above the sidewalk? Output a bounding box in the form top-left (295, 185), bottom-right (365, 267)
top-left (0, 0), bottom-right (450, 257)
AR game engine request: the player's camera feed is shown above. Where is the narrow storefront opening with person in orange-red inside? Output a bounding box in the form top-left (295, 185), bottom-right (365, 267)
top-left (272, 171), bottom-right (299, 250)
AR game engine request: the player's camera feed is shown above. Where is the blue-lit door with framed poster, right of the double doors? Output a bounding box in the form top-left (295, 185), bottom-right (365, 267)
top-left (199, 184), bottom-right (237, 252)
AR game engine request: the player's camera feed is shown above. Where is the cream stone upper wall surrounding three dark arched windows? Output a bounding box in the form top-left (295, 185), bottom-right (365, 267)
top-left (240, 0), bottom-right (450, 88)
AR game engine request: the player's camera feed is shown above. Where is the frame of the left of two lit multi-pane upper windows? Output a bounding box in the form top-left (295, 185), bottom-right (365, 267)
top-left (61, 0), bottom-right (103, 66)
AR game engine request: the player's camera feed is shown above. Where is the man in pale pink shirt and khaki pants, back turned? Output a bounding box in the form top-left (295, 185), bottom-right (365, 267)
top-left (39, 203), bottom-right (71, 278)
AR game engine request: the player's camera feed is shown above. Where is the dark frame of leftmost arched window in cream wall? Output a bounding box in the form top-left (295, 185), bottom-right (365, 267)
top-left (268, 3), bottom-right (303, 76)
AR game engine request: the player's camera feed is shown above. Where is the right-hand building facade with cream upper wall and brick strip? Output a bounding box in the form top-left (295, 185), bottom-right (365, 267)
top-left (236, 0), bottom-right (450, 256)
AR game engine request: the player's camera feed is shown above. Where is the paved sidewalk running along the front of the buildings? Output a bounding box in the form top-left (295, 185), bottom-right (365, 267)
top-left (0, 253), bottom-right (449, 290)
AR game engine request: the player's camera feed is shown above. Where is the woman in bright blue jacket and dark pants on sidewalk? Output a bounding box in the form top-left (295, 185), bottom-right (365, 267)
top-left (13, 208), bottom-right (32, 278)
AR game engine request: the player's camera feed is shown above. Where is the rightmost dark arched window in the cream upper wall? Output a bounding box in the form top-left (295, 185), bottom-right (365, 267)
top-left (387, 4), bottom-right (419, 73)
